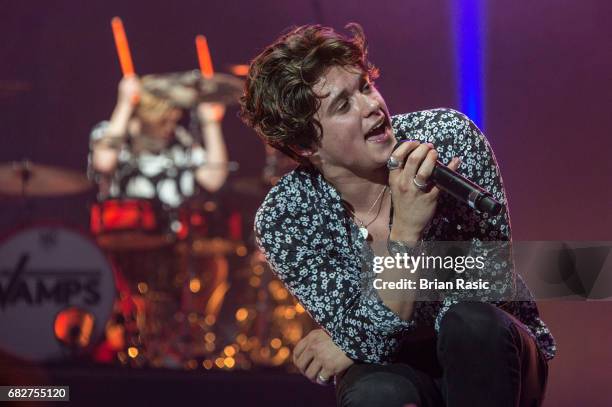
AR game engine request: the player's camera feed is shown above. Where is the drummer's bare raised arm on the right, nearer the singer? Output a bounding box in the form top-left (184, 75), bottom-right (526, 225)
top-left (196, 103), bottom-right (228, 192)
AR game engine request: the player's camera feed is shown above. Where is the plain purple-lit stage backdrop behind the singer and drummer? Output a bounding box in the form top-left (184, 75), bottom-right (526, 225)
top-left (0, 0), bottom-right (612, 406)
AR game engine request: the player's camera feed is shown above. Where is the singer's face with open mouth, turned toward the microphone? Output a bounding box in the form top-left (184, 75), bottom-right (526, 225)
top-left (311, 66), bottom-right (395, 176)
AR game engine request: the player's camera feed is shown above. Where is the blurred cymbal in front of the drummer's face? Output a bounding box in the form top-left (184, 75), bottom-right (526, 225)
top-left (142, 70), bottom-right (244, 108)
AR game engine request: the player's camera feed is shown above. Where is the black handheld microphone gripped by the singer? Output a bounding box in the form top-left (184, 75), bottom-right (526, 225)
top-left (393, 142), bottom-right (503, 216)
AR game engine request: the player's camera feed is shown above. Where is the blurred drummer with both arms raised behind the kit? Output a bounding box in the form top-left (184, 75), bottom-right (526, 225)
top-left (89, 76), bottom-right (228, 208)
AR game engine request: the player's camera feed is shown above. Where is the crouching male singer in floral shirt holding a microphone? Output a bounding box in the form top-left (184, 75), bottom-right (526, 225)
top-left (241, 24), bottom-right (555, 406)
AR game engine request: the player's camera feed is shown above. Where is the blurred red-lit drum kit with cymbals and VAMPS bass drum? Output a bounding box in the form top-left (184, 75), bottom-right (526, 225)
top-left (0, 71), bottom-right (310, 369)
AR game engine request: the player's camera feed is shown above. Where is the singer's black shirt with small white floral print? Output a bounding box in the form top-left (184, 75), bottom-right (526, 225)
top-left (255, 109), bottom-right (556, 363)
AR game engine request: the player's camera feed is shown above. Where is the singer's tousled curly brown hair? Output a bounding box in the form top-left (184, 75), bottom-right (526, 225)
top-left (240, 23), bottom-right (378, 163)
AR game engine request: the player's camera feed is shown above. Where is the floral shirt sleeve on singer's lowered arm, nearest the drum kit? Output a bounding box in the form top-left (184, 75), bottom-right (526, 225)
top-left (255, 190), bottom-right (415, 363)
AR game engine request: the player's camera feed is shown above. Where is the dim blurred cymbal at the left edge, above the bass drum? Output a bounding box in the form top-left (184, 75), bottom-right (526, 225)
top-left (0, 161), bottom-right (91, 196)
